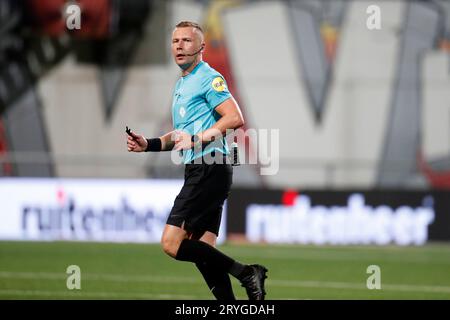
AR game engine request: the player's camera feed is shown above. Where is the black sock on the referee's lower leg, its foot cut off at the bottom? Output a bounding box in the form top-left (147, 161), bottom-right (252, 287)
top-left (195, 263), bottom-right (236, 300)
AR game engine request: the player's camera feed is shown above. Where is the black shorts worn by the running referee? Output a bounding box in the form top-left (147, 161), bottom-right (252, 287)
top-left (166, 154), bottom-right (233, 235)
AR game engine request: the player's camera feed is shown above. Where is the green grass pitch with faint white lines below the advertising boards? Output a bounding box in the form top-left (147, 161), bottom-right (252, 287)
top-left (0, 241), bottom-right (450, 300)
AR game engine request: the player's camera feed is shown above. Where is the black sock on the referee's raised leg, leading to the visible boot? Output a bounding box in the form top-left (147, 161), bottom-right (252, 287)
top-left (175, 239), bottom-right (247, 279)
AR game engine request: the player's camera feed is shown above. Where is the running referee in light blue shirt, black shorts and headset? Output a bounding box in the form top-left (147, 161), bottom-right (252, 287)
top-left (127, 21), bottom-right (267, 300)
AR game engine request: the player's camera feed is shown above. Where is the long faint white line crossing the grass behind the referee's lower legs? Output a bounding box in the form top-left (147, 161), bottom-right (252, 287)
top-left (0, 271), bottom-right (450, 293)
